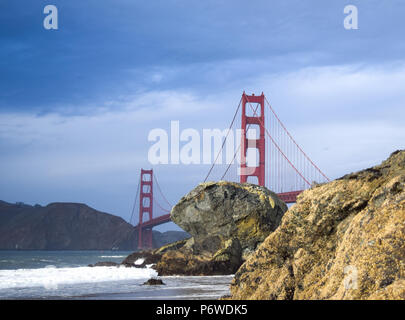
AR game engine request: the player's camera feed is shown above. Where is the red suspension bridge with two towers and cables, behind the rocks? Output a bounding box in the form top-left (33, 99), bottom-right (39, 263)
top-left (130, 92), bottom-right (329, 249)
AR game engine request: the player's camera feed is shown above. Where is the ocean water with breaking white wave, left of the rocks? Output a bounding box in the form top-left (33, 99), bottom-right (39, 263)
top-left (0, 251), bottom-right (232, 300)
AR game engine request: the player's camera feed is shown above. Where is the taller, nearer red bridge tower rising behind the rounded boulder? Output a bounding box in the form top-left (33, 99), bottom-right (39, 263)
top-left (240, 92), bottom-right (266, 186)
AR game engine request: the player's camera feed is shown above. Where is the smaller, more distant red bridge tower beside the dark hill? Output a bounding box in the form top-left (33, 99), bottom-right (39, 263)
top-left (138, 169), bottom-right (153, 249)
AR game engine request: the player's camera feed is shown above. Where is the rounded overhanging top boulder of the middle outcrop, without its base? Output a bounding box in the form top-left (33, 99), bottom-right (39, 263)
top-left (170, 181), bottom-right (287, 256)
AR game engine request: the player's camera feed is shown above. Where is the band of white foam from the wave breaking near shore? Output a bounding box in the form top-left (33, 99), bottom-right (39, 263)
top-left (0, 266), bottom-right (157, 290)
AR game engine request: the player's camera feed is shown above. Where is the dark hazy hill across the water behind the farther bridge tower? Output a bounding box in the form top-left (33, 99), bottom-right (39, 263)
top-left (0, 200), bottom-right (189, 250)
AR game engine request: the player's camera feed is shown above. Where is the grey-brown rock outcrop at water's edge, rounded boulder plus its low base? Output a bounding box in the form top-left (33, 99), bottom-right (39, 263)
top-left (143, 181), bottom-right (287, 275)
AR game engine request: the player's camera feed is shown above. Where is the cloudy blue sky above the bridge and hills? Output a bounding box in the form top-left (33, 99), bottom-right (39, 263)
top-left (0, 0), bottom-right (405, 230)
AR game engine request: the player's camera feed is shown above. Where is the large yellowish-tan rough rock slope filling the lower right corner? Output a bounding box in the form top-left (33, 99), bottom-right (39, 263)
top-left (231, 151), bottom-right (405, 299)
